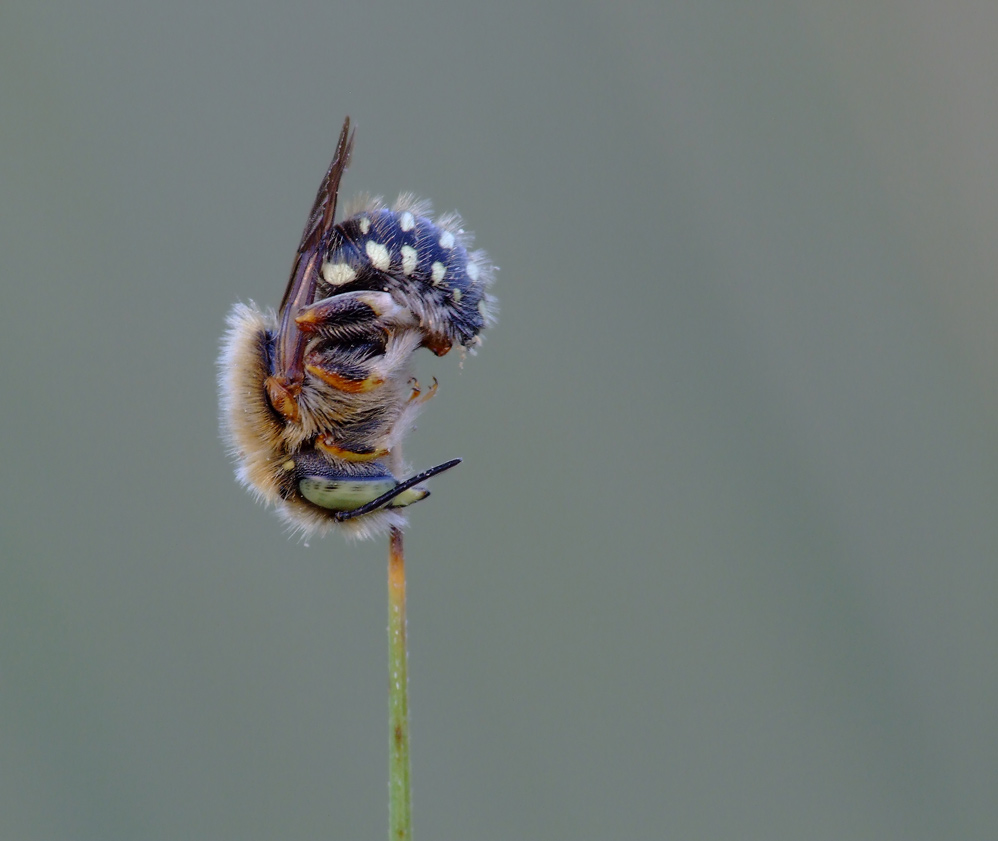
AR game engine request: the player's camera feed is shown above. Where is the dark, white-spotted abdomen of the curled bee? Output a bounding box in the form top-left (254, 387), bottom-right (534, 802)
top-left (318, 198), bottom-right (494, 351)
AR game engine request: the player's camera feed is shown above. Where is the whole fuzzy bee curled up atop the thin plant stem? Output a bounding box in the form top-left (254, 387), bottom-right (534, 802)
top-left (218, 117), bottom-right (495, 537)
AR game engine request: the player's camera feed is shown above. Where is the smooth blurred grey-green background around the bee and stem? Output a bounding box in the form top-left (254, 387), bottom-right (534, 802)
top-left (0, 0), bottom-right (998, 841)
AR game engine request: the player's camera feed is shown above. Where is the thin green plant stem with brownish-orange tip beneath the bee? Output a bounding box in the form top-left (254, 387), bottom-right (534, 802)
top-left (388, 528), bottom-right (412, 841)
